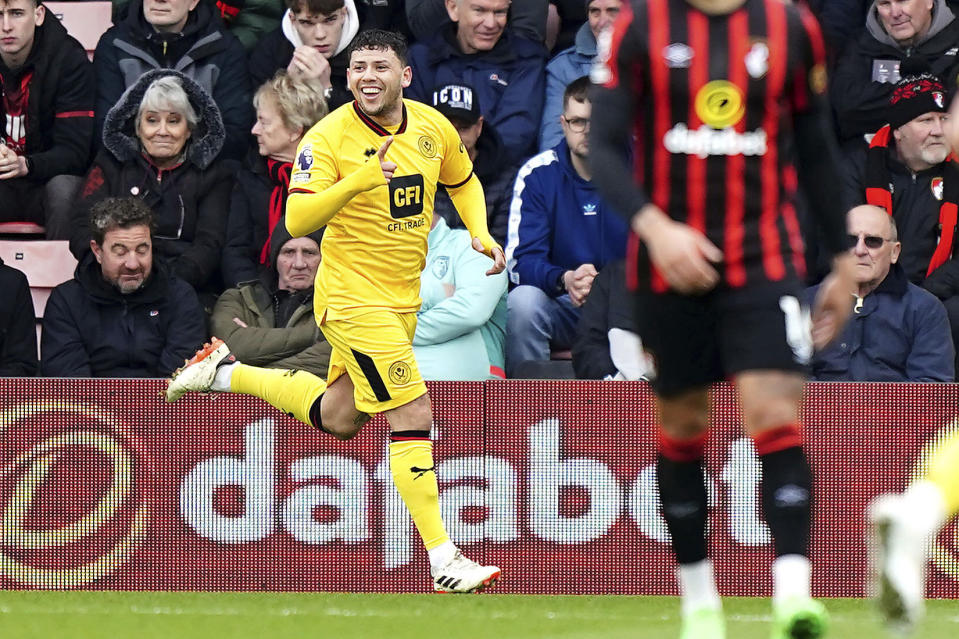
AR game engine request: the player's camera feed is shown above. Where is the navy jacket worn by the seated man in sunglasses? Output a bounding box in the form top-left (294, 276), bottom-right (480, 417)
top-left (806, 264), bottom-right (955, 382)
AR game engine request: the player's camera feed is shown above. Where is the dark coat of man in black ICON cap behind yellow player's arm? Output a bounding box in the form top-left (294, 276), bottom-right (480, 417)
top-left (433, 122), bottom-right (519, 246)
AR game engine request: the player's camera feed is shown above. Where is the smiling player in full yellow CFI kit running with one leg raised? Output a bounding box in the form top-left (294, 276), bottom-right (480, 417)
top-left (167, 30), bottom-right (506, 592)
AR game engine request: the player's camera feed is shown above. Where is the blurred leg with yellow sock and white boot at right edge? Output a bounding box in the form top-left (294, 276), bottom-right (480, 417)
top-left (869, 422), bottom-right (959, 631)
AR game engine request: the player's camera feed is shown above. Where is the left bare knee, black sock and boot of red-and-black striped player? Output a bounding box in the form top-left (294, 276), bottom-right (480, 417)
top-left (656, 390), bottom-right (726, 639)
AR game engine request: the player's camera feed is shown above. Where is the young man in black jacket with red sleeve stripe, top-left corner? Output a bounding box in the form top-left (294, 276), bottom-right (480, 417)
top-left (0, 0), bottom-right (94, 240)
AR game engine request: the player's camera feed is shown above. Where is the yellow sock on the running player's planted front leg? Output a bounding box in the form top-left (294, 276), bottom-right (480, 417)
top-left (390, 430), bottom-right (449, 550)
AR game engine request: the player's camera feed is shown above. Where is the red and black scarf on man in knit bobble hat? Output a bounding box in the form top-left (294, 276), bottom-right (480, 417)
top-left (866, 124), bottom-right (959, 277)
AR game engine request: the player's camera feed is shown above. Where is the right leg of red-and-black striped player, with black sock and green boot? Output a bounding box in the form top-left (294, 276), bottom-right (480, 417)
top-left (736, 371), bottom-right (828, 639)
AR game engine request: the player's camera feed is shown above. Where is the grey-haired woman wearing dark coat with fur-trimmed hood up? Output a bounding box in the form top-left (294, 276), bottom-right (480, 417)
top-left (70, 69), bottom-right (233, 292)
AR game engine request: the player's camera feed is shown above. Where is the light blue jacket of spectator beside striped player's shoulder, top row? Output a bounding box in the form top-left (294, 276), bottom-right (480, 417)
top-left (539, 22), bottom-right (596, 151)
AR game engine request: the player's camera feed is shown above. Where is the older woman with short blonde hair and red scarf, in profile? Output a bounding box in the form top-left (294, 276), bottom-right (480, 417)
top-left (223, 70), bottom-right (327, 286)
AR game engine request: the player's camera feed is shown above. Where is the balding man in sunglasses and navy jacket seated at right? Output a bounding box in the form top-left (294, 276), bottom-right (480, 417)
top-left (808, 204), bottom-right (954, 382)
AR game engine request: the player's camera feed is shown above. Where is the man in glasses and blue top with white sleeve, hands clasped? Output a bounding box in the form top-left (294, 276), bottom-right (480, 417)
top-left (506, 76), bottom-right (628, 376)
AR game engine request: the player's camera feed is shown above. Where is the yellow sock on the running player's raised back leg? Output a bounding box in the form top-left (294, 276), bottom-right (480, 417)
top-left (230, 364), bottom-right (326, 426)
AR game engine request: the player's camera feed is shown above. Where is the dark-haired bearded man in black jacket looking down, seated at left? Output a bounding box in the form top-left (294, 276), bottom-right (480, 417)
top-left (40, 197), bottom-right (206, 377)
